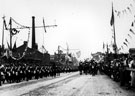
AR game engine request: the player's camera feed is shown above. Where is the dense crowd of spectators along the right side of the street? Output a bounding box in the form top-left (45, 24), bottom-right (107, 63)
top-left (100, 56), bottom-right (135, 88)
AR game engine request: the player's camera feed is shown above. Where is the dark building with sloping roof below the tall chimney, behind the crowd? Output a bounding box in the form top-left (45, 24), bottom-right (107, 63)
top-left (4, 41), bottom-right (50, 65)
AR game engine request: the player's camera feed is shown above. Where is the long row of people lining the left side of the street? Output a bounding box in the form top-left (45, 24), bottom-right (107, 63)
top-left (0, 64), bottom-right (76, 86)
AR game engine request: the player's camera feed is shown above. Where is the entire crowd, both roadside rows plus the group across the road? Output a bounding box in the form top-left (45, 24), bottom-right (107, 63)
top-left (0, 55), bottom-right (135, 88)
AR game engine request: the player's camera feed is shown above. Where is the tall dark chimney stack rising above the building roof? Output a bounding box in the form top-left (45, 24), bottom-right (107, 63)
top-left (32, 16), bottom-right (36, 49)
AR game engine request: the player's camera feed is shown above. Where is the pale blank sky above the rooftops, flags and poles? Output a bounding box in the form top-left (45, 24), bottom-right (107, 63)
top-left (0, 0), bottom-right (135, 59)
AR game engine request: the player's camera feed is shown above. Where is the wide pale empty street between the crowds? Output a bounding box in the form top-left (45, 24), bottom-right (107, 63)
top-left (0, 72), bottom-right (135, 96)
